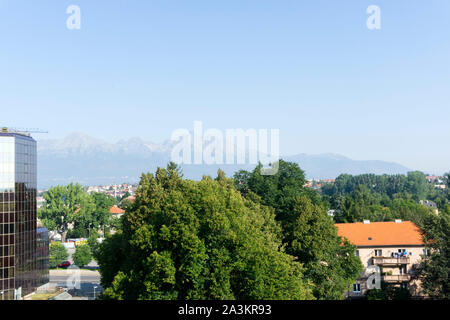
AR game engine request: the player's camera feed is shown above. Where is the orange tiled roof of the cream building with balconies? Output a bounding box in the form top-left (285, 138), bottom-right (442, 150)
top-left (335, 221), bottom-right (424, 247)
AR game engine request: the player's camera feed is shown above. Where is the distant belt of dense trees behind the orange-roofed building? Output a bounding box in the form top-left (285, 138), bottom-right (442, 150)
top-left (321, 172), bottom-right (450, 224)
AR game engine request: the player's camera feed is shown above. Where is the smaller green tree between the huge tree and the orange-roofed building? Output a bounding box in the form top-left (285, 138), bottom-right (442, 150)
top-left (284, 195), bottom-right (363, 300)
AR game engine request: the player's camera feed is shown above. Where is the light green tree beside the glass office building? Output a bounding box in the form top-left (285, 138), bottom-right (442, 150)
top-left (39, 183), bottom-right (95, 242)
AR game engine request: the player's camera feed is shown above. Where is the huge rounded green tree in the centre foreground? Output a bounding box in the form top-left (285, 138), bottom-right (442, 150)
top-left (97, 165), bottom-right (313, 300)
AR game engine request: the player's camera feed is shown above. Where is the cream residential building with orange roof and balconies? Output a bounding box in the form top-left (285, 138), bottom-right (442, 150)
top-left (336, 220), bottom-right (427, 298)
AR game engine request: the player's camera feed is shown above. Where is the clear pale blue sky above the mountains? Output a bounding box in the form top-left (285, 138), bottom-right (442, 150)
top-left (0, 0), bottom-right (450, 173)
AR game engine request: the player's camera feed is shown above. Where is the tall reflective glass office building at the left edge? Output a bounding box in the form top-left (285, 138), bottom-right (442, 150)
top-left (0, 130), bottom-right (39, 300)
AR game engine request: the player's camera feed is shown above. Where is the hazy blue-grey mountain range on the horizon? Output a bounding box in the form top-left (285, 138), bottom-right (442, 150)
top-left (38, 133), bottom-right (411, 188)
